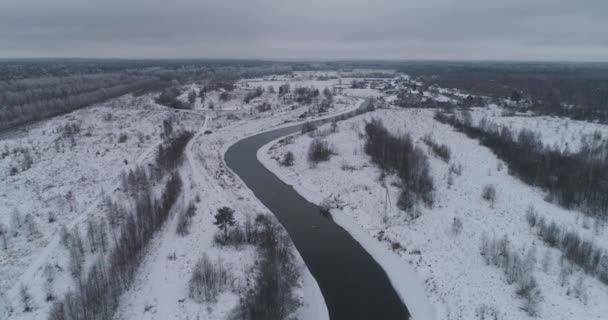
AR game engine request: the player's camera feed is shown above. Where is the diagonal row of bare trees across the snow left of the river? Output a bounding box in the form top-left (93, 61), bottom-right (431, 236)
top-left (49, 132), bottom-right (192, 320)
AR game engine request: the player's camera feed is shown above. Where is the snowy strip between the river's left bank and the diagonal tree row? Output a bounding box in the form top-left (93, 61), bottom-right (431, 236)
top-left (116, 94), bottom-right (357, 319)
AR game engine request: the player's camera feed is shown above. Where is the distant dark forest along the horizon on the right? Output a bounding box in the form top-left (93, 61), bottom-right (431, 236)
top-left (400, 63), bottom-right (608, 123)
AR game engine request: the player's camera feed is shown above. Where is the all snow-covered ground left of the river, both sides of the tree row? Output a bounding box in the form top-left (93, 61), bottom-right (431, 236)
top-left (0, 75), bottom-right (366, 319)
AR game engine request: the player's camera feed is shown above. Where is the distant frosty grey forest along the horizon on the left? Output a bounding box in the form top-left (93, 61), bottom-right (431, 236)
top-left (0, 60), bottom-right (293, 130)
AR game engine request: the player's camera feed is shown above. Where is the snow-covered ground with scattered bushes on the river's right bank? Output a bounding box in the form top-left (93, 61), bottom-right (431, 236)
top-left (258, 109), bottom-right (608, 319)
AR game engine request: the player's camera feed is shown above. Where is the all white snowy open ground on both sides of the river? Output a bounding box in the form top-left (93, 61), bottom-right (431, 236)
top-left (0, 70), bottom-right (608, 320)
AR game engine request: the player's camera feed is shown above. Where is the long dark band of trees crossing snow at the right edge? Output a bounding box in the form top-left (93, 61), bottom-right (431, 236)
top-left (435, 112), bottom-right (608, 218)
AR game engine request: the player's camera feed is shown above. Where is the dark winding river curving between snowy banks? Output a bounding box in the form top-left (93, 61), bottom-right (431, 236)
top-left (225, 102), bottom-right (409, 320)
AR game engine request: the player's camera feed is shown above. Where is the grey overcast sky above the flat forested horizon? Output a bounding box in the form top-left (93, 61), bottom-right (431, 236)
top-left (0, 0), bottom-right (608, 61)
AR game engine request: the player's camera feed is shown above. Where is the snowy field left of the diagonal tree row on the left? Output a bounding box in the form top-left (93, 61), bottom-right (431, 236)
top-left (0, 95), bottom-right (208, 316)
